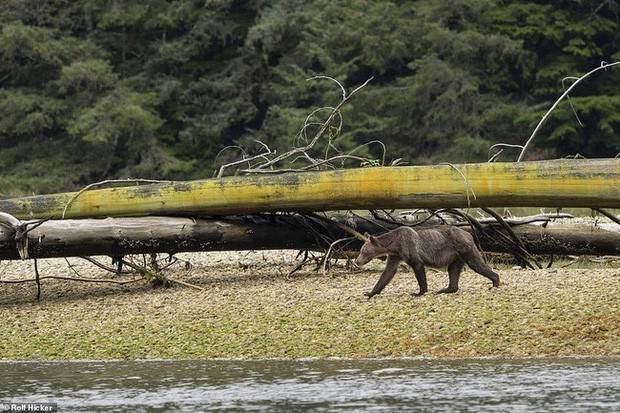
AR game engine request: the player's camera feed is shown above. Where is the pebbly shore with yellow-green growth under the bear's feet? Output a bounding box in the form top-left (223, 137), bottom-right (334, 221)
top-left (0, 252), bottom-right (620, 359)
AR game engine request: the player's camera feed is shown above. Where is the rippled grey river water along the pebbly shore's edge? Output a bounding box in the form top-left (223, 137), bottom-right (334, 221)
top-left (0, 358), bottom-right (620, 413)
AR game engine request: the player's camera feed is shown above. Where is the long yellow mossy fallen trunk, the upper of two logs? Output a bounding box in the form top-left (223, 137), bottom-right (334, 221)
top-left (0, 159), bottom-right (620, 219)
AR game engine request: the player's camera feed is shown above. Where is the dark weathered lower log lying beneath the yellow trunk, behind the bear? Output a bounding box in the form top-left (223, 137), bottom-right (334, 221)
top-left (0, 214), bottom-right (620, 260)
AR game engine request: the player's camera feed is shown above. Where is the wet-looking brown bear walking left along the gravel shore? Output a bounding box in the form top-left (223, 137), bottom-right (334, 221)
top-left (355, 226), bottom-right (499, 298)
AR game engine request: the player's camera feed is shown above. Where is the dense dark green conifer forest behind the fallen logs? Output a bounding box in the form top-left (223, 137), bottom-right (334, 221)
top-left (0, 0), bottom-right (620, 197)
